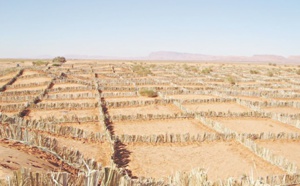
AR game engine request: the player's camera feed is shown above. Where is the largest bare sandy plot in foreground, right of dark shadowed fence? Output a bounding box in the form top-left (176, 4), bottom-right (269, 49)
top-left (127, 142), bottom-right (283, 180)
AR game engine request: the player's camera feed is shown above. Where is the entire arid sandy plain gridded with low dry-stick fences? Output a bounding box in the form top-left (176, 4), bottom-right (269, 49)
top-left (0, 59), bottom-right (300, 185)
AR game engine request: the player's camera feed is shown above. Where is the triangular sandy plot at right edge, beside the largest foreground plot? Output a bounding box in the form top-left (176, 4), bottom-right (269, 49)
top-left (256, 140), bottom-right (300, 167)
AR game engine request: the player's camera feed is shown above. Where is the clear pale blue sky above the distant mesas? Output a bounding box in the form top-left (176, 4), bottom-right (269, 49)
top-left (0, 0), bottom-right (300, 57)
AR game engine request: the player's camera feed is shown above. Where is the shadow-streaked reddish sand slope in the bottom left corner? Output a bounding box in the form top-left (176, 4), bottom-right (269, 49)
top-left (0, 143), bottom-right (57, 179)
